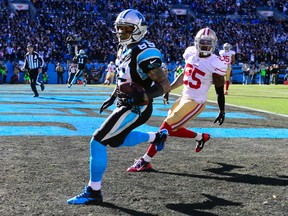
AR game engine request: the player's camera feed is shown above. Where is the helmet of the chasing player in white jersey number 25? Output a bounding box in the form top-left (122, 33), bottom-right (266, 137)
top-left (195, 27), bottom-right (218, 55)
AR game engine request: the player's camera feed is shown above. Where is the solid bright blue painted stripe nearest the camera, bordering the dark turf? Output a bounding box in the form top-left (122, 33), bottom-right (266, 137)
top-left (0, 125), bottom-right (288, 138)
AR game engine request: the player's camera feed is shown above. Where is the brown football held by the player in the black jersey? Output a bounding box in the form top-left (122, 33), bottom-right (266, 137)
top-left (119, 82), bottom-right (149, 105)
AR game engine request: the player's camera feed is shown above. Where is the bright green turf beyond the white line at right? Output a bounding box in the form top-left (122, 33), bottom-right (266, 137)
top-left (173, 84), bottom-right (288, 115)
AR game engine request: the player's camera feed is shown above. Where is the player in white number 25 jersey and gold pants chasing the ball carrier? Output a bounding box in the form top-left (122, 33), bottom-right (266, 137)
top-left (127, 28), bottom-right (227, 172)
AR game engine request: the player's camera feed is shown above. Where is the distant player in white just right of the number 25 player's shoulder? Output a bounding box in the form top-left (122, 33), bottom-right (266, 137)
top-left (219, 43), bottom-right (235, 95)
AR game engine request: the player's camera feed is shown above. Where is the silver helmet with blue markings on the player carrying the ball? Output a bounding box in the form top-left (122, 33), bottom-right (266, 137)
top-left (114, 9), bottom-right (147, 45)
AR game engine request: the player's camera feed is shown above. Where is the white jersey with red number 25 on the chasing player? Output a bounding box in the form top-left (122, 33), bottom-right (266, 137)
top-left (182, 46), bottom-right (227, 104)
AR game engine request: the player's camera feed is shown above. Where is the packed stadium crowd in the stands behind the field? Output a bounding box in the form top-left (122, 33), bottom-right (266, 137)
top-left (0, 0), bottom-right (288, 67)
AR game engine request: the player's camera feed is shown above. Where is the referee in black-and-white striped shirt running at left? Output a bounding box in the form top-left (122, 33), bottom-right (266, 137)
top-left (21, 44), bottom-right (45, 97)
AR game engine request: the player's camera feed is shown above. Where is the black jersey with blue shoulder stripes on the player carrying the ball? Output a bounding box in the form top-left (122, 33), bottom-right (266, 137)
top-left (117, 40), bottom-right (162, 89)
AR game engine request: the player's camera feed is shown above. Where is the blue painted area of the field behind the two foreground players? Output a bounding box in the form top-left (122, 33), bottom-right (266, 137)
top-left (0, 85), bottom-right (288, 139)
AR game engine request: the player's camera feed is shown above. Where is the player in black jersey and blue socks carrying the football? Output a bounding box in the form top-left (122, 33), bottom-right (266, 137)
top-left (67, 9), bottom-right (170, 204)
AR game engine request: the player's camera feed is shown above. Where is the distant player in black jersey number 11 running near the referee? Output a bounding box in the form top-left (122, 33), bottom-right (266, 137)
top-left (67, 50), bottom-right (88, 88)
